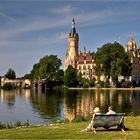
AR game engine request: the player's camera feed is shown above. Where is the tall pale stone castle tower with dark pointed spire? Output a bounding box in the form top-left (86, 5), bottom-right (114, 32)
top-left (64, 18), bottom-right (79, 71)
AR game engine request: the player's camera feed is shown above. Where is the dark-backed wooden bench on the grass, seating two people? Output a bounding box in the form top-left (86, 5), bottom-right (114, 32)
top-left (93, 113), bottom-right (125, 133)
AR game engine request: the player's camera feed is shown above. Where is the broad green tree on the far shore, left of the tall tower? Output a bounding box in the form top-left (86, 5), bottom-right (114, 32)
top-left (28, 55), bottom-right (64, 88)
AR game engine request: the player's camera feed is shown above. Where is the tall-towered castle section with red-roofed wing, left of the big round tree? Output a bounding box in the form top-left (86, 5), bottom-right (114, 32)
top-left (64, 18), bottom-right (94, 78)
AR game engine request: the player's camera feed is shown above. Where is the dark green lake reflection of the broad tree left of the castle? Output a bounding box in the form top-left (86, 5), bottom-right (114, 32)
top-left (30, 91), bottom-right (64, 120)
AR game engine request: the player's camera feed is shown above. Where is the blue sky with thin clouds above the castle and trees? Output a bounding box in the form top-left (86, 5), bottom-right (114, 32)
top-left (0, 0), bottom-right (140, 77)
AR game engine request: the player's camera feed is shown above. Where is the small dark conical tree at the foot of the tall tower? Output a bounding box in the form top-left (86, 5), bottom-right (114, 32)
top-left (64, 65), bottom-right (78, 87)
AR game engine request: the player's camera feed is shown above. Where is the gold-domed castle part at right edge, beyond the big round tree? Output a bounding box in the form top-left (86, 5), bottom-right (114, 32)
top-left (125, 38), bottom-right (140, 82)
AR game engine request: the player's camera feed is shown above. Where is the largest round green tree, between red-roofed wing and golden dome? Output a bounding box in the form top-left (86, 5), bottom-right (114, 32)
top-left (95, 42), bottom-right (131, 84)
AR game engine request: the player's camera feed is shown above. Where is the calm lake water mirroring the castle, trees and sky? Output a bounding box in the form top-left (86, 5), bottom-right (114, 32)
top-left (0, 89), bottom-right (140, 124)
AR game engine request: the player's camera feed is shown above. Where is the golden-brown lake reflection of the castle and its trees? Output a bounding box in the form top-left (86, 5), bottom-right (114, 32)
top-left (64, 89), bottom-right (140, 120)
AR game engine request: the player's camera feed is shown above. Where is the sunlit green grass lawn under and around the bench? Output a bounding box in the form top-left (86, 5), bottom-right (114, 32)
top-left (0, 116), bottom-right (140, 140)
